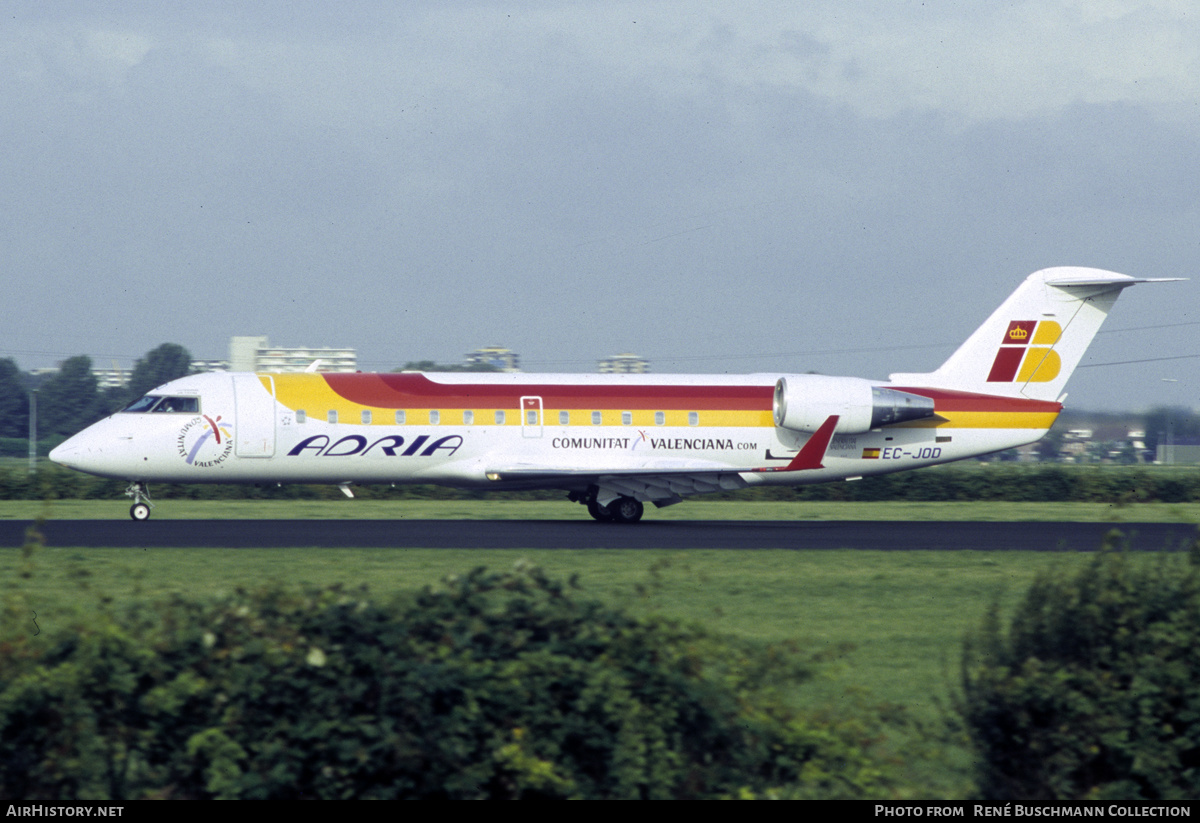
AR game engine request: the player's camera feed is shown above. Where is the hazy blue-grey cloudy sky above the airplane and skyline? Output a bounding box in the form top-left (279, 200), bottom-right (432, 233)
top-left (0, 0), bottom-right (1200, 408)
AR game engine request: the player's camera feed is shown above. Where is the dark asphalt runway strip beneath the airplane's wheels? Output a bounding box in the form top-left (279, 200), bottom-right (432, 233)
top-left (0, 519), bottom-right (1196, 552)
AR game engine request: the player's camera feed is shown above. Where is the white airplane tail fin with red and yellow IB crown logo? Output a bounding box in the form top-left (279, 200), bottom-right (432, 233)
top-left (889, 266), bottom-right (1175, 401)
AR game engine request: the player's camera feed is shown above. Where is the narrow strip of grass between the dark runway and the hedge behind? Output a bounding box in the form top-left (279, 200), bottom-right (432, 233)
top-left (0, 499), bottom-right (1200, 523)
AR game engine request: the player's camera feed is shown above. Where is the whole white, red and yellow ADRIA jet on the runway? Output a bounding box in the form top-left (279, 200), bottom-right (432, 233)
top-left (50, 266), bottom-right (1178, 523)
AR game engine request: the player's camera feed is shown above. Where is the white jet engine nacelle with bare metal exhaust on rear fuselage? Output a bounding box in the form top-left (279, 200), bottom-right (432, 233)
top-left (773, 374), bottom-right (935, 434)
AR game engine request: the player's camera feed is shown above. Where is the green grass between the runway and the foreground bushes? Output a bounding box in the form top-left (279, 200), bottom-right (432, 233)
top-left (0, 547), bottom-right (1113, 705)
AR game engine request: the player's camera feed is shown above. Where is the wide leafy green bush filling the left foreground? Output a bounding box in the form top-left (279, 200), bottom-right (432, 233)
top-left (0, 569), bottom-right (889, 800)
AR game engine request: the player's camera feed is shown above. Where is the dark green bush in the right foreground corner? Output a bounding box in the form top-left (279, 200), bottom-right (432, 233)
top-left (961, 535), bottom-right (1200, 800)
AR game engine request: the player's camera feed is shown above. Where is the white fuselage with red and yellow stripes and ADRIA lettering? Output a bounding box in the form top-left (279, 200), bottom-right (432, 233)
top-left (53, 372), bottom-right (1056, 489)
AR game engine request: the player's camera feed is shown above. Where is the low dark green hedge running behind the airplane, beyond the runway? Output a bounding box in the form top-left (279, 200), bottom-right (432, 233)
top-left (0, 463), bottom-right (1200, 504)
